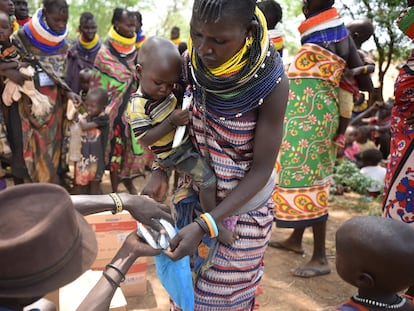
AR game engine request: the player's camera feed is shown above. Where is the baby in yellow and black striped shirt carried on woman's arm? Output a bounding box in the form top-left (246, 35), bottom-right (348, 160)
top-left (128, 37), bottom-right (234, 244)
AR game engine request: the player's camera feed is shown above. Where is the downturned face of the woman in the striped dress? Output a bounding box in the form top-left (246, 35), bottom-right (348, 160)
top-left (190, 17), bottom-right (249, 68)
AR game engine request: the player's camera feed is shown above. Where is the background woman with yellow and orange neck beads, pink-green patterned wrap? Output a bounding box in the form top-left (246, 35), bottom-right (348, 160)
top-left (94, 8), bottom-right (152, 194)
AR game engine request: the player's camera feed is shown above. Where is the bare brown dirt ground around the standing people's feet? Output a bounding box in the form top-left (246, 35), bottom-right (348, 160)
top-left (100, 174), bottom-right (379, 311)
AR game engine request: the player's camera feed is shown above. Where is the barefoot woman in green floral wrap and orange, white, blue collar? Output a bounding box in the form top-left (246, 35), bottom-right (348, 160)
top-left (271, 0), bottom-right (372, 277)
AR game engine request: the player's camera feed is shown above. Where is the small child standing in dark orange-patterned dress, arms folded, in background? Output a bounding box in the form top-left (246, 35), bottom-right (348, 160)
top-left (75, 88), bottom-right (109, 194)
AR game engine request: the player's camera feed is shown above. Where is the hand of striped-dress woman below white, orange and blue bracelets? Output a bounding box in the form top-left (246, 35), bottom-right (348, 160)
top-left (164, 222), bottom-right (204, 261)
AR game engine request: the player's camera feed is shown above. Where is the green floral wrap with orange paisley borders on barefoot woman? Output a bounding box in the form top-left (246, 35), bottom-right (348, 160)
top-left (273, 43), bottom-right (345, 228)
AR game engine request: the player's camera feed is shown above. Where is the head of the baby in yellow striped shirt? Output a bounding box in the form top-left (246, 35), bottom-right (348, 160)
top-left (137, 36), bottom-right (182, 100)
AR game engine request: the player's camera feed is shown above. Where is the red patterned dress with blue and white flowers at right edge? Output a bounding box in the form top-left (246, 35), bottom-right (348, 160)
top-left (383, 50), bottom-right (414, 224)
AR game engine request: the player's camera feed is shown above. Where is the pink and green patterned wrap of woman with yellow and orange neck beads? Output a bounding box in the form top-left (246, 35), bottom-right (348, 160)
top-left (94, 42), bottom-right (153, 179)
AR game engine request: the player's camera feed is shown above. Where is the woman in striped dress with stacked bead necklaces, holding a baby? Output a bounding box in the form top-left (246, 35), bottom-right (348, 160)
top-left (144, 0), bottom-right (288, 310)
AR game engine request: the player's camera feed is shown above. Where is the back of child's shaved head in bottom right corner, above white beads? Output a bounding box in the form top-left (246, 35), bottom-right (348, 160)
top-left (336, 216), bottom-right (414, 295)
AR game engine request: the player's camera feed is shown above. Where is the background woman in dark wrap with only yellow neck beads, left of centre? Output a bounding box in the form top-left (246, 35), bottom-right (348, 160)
top-left (66, 12), bottom-right (101, 94)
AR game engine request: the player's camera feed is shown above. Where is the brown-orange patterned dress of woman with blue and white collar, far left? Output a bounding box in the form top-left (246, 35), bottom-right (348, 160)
top-left (10, 29), bottom-right (69, 183)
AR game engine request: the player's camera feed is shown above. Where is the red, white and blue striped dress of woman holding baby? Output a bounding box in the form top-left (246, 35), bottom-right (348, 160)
top-left (172, 105), bottom-right (273, 311)
